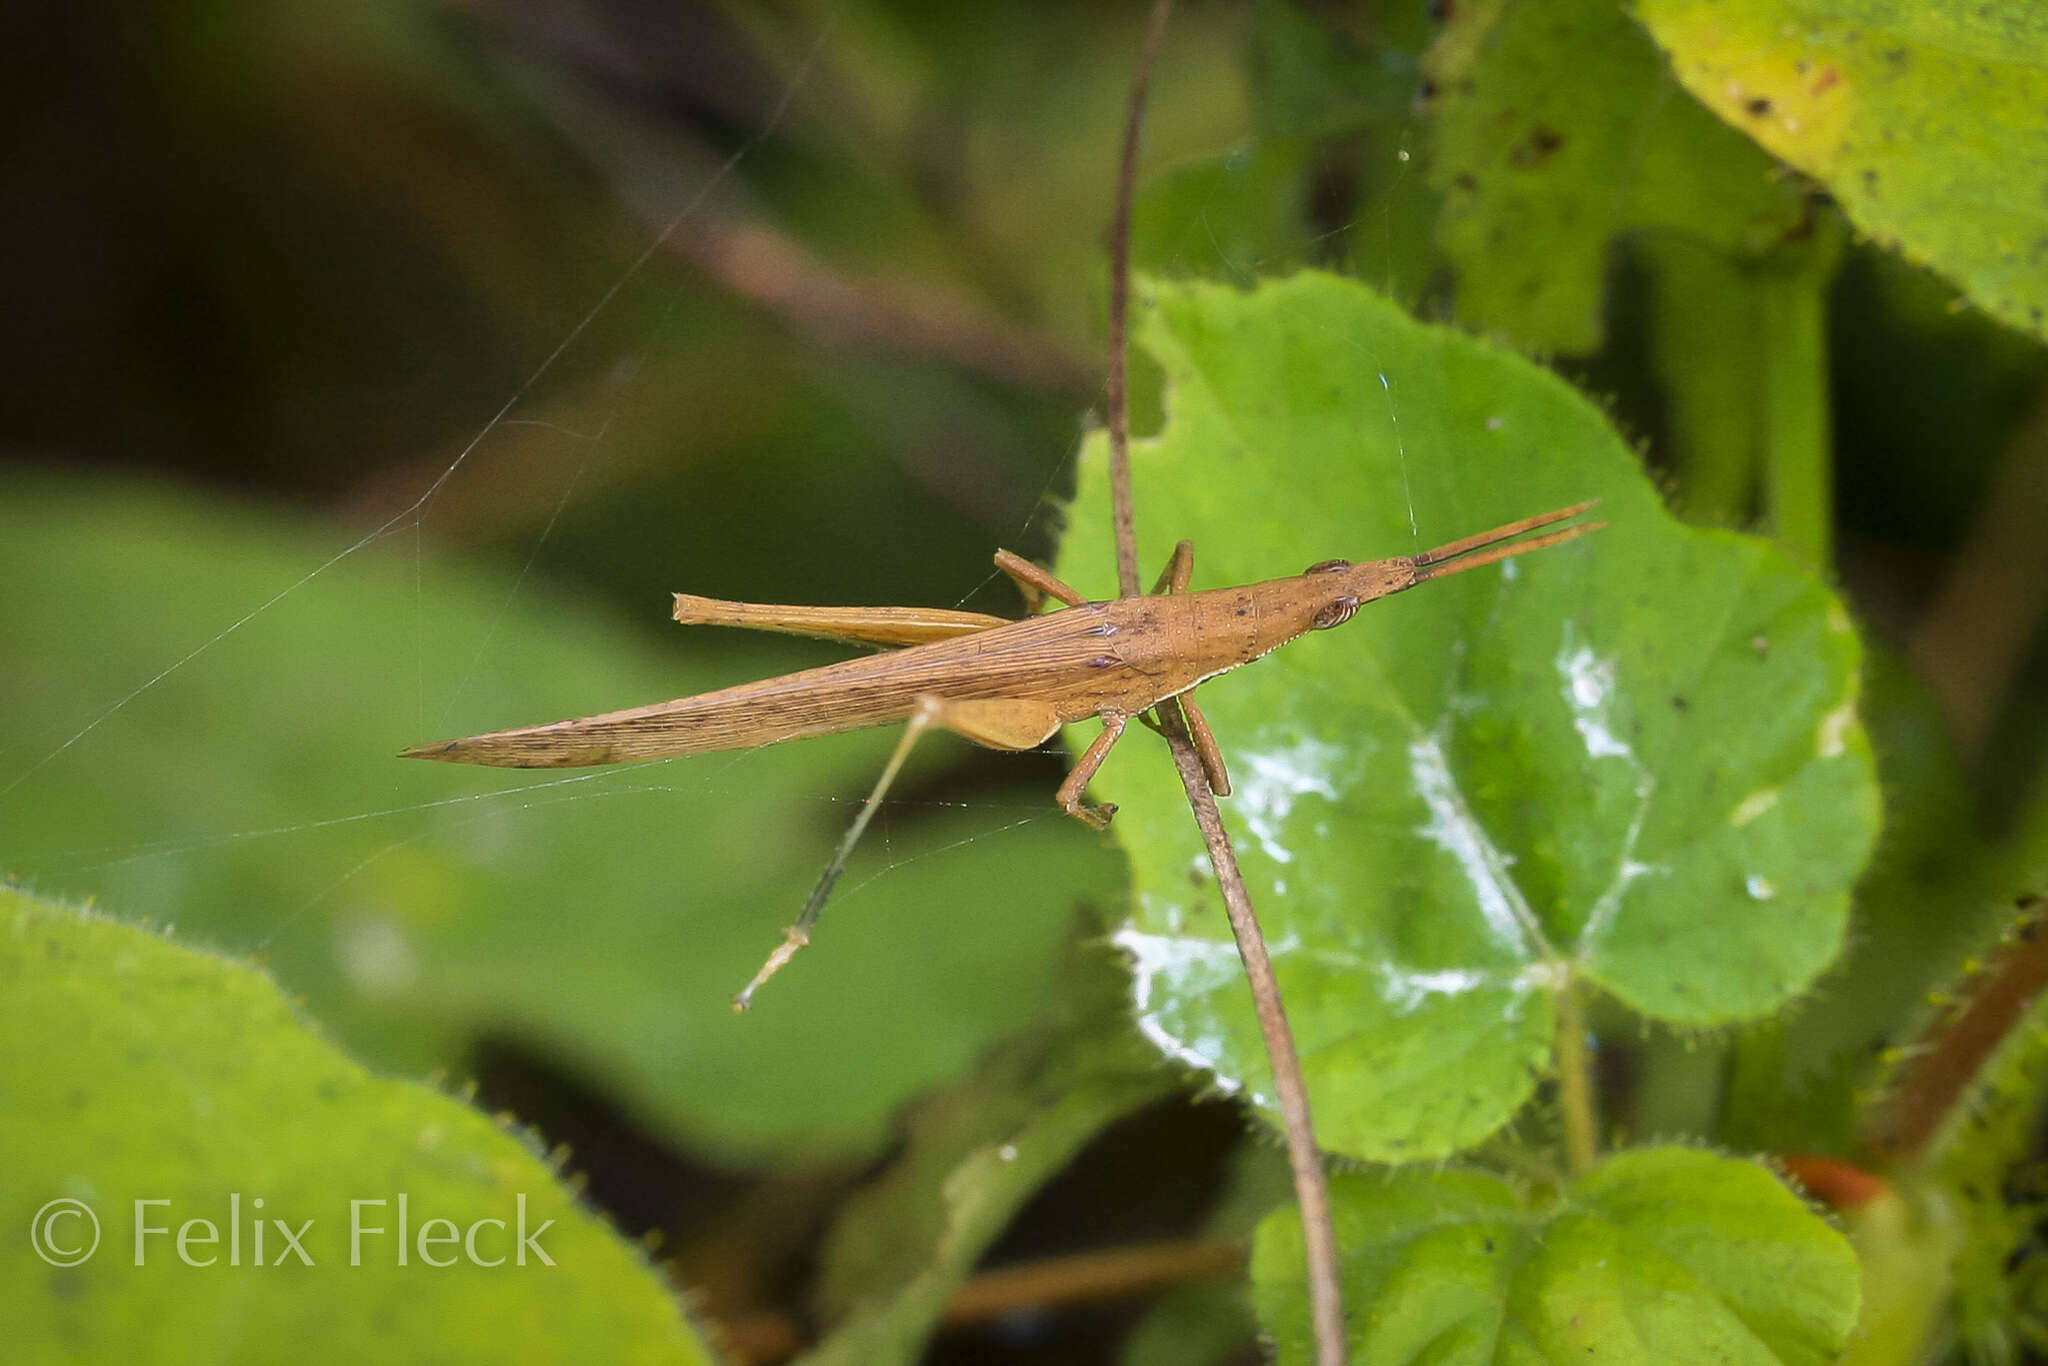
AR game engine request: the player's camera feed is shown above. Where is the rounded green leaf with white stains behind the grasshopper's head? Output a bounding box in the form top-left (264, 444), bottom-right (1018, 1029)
top-left (1061, 274), bottom-right (1878, 1161)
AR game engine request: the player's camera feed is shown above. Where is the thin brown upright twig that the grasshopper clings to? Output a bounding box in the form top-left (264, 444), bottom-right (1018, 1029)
top-left (1106, 0), bottom-right (1346, 1366)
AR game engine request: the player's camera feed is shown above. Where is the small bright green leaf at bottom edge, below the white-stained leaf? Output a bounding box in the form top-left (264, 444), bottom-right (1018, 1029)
top-left (1251, 1147), bottom-right (1858, 1366)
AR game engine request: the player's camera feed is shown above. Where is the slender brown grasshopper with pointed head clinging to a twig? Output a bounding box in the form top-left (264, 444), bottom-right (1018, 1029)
top-left (401, 500), bottom-right (1606, 1010)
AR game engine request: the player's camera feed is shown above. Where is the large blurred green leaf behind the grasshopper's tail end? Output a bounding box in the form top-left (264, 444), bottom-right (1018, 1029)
top-left (0, 481), bottom-right (1118, 1161)
